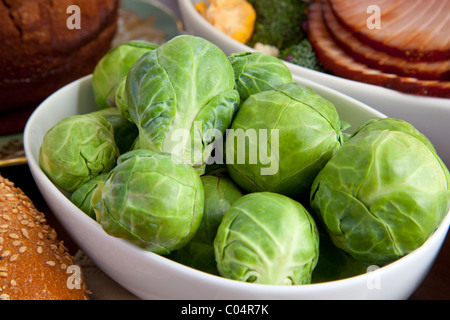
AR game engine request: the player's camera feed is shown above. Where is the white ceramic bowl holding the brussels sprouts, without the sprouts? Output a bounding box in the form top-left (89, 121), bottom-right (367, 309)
top-left (24, 76), bottom-right (450, 300)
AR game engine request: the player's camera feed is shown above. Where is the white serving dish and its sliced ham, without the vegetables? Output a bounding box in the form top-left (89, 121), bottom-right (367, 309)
top-left (178, 0), bottom-right (450, 166)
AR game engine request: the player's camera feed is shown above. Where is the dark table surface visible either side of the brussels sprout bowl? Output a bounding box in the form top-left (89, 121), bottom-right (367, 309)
top-left (0, 164), bottom-right (450, 300)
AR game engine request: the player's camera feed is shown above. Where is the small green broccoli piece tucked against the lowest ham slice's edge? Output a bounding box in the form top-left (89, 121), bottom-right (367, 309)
top-left (280, 38), bottom-right (327, 72)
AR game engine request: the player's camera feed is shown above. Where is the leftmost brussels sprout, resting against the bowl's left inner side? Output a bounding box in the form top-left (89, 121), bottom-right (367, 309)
top-left (39, 114), bottom-right (119, 192)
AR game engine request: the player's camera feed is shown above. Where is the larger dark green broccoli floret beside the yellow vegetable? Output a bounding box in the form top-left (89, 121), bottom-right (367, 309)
top-left (247, 0), bottom-right (309, 50)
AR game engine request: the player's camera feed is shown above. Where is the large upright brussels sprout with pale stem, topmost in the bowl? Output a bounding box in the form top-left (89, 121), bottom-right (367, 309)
top-left (124, 35), bottom-right (240, 173)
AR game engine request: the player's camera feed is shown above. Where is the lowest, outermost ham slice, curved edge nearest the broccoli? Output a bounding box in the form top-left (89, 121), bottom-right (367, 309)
top-left (308, 0), bottom-right (450, 98)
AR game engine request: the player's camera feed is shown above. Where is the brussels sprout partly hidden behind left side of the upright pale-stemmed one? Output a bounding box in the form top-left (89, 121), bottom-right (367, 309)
top-left (92, 40), bottom-right (159, 109)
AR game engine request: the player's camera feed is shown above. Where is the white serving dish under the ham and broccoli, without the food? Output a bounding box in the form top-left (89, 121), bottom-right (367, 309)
top-left (178, 0), bottom-right (450, 167)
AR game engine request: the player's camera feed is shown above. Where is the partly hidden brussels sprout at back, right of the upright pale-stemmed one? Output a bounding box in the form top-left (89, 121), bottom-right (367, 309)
top-left (228, 52), bottom-right (293, 101)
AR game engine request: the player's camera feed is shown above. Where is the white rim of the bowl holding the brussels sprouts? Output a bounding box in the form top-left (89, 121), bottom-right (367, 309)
top-left (24, 74), bottom-right (450, 294)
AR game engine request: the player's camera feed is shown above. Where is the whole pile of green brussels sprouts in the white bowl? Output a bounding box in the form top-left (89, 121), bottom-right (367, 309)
top-left (39, 35), bottom-right (450, 285)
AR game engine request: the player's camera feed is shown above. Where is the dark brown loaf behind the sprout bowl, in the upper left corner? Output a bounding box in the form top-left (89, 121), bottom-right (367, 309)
top-left (0, 0), bottom-right (119, 134)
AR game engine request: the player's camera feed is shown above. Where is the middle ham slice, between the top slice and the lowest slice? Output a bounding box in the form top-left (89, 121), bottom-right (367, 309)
top-left (322, 0), bottom-right (450, 81)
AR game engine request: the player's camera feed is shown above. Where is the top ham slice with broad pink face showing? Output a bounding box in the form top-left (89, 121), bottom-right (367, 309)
top-left (330, 0), bottom-right (450, 61)
